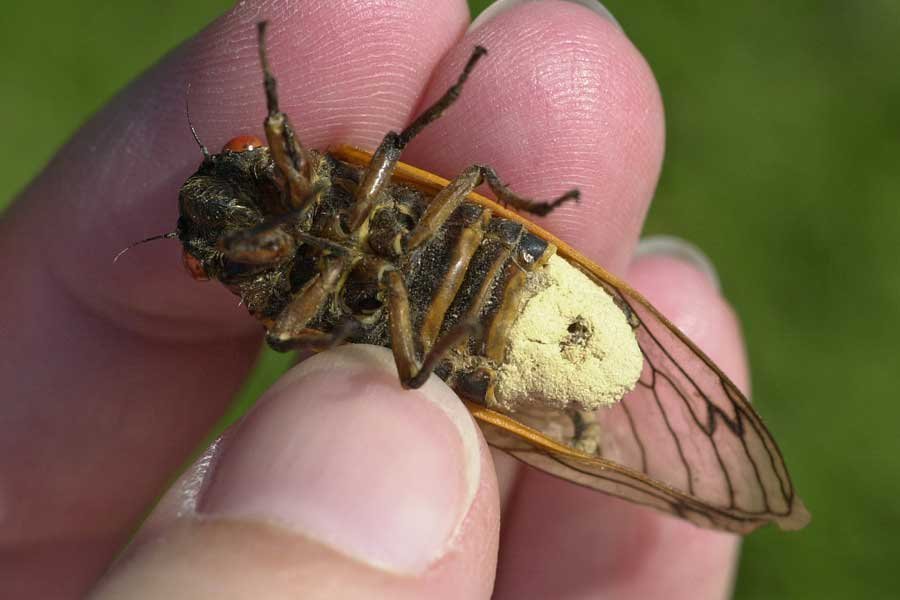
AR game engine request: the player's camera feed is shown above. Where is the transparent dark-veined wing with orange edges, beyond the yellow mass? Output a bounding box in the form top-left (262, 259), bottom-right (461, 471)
top-left (470, 262), bottom-right (809, 533)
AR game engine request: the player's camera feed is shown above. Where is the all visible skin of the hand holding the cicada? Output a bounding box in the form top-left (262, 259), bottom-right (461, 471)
top-left (0, 0), bottom-right (747, 599)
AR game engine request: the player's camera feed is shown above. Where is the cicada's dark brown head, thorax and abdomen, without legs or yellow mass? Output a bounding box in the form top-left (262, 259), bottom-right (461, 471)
top-left (178, 141), bottom-right (554, 401)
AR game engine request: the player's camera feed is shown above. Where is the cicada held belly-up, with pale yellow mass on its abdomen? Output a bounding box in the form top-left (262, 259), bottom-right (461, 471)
top-left (176, 23), bottom-right (809, 533)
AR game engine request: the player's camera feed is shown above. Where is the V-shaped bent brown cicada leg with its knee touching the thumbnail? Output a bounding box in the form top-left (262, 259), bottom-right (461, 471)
top-left (385, 271), bottom-right (480, 389)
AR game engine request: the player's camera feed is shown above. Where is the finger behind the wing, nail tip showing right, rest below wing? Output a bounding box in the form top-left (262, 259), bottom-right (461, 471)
top-left (497, 241), bottom-right (747, 599)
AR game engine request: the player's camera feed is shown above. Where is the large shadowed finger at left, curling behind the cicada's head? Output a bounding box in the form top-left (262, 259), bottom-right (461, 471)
top-left (0, 0), bottom-right (468, 597)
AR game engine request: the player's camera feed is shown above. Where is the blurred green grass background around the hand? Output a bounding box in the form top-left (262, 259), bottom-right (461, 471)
top-left (0, 0), bottom-right (900, 598)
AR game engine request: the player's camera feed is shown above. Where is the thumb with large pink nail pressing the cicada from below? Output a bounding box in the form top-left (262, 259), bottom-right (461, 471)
top-left (95, 346), bottom-right (499, 599)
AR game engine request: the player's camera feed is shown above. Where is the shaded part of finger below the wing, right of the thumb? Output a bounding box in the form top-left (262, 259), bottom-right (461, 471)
top-left (494, 478), bottom-right (740, 600)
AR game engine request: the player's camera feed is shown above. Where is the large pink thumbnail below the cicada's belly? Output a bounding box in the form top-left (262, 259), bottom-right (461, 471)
top-left (200, 345), bottom-right (481, 573)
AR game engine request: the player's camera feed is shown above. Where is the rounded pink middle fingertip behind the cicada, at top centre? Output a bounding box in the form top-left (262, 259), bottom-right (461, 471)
top-left (404, 1), bottom-right (664, 506)
